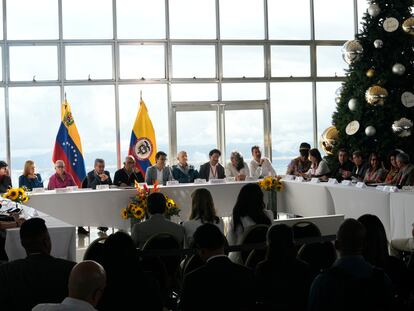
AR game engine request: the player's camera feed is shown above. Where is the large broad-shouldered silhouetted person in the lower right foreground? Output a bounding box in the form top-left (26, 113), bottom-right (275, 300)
top-left (308, 218), bottom-right (394, 311)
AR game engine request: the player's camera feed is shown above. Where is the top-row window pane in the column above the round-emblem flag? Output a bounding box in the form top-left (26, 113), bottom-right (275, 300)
top-left (116, 0), bottom-right (165, 39)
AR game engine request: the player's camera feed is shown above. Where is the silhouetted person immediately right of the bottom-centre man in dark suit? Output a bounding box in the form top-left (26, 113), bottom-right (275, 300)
top-left (256, 224), bottom-right (312, 311)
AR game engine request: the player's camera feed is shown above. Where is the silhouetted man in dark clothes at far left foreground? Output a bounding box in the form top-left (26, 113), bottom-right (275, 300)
top-left (0, 218), bottom-right (75, 311)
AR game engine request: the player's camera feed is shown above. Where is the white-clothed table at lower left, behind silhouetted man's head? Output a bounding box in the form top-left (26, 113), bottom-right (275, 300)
top-left (5, 212), bottom-right (76, 261)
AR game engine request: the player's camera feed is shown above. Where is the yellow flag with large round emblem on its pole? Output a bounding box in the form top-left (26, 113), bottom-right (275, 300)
top-left (128, 99), bottom-right (157, 177)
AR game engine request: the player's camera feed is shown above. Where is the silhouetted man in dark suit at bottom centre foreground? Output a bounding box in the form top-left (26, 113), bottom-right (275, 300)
top-left (181, 223), bottom-right (255, 311)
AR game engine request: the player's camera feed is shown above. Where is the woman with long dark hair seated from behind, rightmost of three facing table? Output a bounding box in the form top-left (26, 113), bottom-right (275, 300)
top-left (227, 183), bottom-right (273, 262)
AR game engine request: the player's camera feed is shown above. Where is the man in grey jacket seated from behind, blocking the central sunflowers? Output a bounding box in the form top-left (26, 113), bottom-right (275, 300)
top-left (131, 192), bottom-right (184, 247)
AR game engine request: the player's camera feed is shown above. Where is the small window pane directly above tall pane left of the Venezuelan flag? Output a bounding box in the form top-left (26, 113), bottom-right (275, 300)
top-left (9, 45), bottom-right (58, 82)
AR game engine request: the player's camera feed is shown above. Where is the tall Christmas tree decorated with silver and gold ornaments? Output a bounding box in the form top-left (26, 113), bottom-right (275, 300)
top-left (330, 0), bottom-right (414, 159)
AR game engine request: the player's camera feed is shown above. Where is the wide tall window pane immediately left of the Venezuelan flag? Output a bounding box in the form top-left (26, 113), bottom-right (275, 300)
top-left (9, 87), bottom-right (60, 185)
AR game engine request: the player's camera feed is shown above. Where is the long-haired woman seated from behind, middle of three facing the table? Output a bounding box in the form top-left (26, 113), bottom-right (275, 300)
top-left (183, 188), bottom-right (224, 247)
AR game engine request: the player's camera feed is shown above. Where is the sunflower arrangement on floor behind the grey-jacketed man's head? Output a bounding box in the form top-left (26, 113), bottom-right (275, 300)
top-left (121, 182), bottom-right (180, 220)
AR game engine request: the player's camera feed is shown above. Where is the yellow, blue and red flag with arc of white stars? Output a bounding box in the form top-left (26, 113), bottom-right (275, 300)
top-left (52, 99), bottom-right (86, 187)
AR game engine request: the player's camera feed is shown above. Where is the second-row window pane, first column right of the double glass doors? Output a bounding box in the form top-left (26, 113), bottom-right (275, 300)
top-left (271, 46), bottom-right (310, 77)
